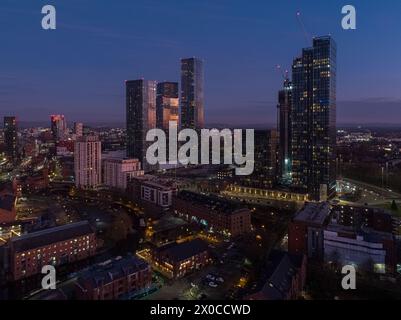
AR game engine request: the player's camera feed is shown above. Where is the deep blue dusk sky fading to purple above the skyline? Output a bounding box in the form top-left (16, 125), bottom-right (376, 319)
top-left (0, 1), bottom-right (401, 126)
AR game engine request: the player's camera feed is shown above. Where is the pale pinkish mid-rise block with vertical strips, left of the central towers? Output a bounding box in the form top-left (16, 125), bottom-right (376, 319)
top-left (74, 136), bottom-right (102, 189)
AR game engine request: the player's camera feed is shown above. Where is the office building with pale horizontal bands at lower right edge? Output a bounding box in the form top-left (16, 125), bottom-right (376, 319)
top-left (324, 205), bottom-right (397, 273)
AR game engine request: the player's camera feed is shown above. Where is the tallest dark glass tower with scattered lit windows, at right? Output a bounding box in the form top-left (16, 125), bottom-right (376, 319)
top-left (291, 36), bottom-right (336, 200)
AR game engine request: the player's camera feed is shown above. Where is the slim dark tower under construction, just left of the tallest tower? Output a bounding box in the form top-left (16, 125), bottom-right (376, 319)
top-left (277, 79), bottom-right (292, 184)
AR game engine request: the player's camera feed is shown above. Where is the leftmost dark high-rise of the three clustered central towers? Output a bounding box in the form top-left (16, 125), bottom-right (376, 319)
top-left (125, 80), bottom-right (156, 171)
